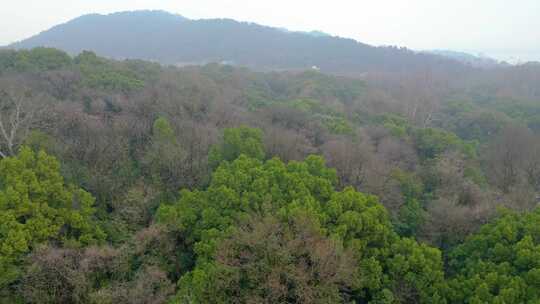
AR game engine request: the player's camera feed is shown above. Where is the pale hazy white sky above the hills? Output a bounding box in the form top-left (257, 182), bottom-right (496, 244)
top-left (0, 0), bottom-right (540, 62)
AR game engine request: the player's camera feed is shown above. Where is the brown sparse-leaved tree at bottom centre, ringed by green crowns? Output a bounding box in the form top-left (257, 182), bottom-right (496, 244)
top-left (184, 216), bottom-right (359, 303)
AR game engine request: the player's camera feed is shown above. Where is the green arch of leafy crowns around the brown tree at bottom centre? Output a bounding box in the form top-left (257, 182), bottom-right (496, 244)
top-left (158, 155), bottom-right (443, 303)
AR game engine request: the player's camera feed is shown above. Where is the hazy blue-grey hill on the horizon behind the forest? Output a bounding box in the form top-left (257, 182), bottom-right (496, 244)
top-left (10, 11), bottom-right (465, 74)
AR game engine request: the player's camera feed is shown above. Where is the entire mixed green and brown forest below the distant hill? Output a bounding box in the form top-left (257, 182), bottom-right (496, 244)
top-left (0, 47), bottom-right (540, 304)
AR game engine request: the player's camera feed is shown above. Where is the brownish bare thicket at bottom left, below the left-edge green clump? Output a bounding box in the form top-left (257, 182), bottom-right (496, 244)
top-left (20, 226), bottom-right (178, 304)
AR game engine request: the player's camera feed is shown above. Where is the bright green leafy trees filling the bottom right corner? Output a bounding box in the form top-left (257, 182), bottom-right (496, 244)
top-left (448, 209), bottom-right (540, 304)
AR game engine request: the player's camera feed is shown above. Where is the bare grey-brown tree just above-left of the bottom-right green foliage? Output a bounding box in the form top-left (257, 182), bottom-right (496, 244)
top-left (422, 152), bottom-right (500, 248)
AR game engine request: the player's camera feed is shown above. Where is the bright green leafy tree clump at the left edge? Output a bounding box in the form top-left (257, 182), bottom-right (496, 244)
top-left (0, 147), bottom-right (104, 286)
